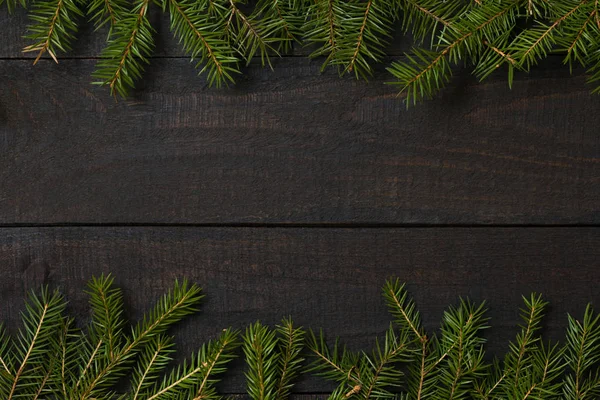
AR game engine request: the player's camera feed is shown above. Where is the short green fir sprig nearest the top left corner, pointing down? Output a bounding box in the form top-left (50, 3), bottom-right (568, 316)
top-left (22, 0), bottom-right (82, 64)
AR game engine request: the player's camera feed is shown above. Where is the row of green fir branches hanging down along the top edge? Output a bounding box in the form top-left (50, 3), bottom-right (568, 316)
top-left (11, 0), bottom-right (600, 106)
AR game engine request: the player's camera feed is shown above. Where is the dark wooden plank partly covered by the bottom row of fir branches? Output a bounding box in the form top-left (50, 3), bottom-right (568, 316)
top-left (0, 227), bottom-right (600, 393)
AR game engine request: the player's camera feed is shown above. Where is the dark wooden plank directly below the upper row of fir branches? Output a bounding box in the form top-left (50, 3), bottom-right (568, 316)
top-left (0, 59), bottom-right (600, 224)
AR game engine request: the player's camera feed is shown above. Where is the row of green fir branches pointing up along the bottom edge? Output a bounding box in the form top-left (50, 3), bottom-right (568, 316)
top-left (0, 276), bottom-right (600, 400)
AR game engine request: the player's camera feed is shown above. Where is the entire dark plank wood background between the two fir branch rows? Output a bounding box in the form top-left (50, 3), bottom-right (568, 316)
top-left (0, 9), bottom-right (600, 399)
